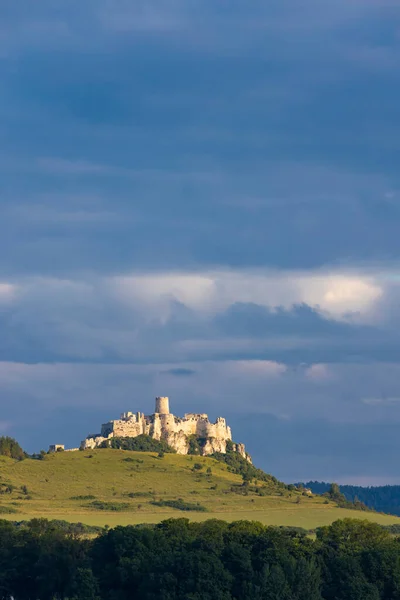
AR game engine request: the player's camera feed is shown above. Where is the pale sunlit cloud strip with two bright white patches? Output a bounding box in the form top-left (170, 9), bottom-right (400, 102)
top-left (110, 270), bottom-right (384, 321)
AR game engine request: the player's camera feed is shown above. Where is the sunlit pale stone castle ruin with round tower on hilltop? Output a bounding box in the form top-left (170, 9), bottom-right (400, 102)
top-left (81, 396), bottom-right (251, 462)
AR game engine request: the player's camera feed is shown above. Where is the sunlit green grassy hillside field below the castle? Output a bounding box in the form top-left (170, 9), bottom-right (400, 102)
top-left (0, 449), bottom-right (400, 529)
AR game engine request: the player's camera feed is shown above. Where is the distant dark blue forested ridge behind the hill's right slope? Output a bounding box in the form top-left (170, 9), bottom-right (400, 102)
top-left (296, 481), bottom-right (400, 516)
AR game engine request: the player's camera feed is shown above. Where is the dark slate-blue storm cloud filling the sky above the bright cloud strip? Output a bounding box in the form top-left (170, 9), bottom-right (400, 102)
top-left (0, 1), bottom-right (400, 274)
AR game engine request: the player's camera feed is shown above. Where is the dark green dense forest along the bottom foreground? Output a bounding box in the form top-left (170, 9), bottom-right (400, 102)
top-left (0, 519), bottom-right (400, 600)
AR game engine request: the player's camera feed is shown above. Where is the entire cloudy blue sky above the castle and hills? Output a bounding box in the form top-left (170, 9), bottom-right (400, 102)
top-left (0, 0), bottom-right (400, 485)
